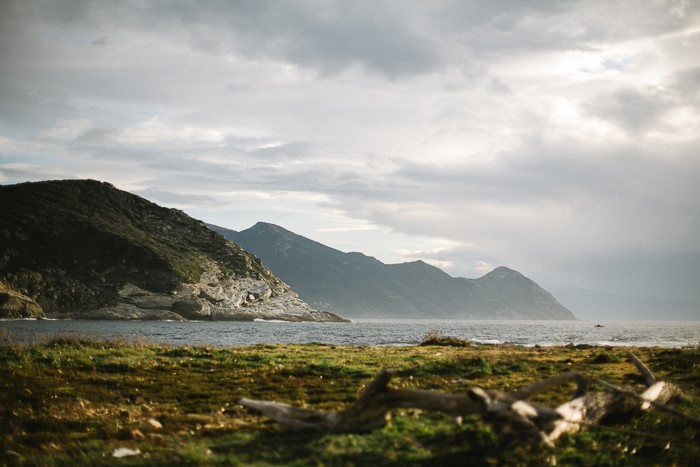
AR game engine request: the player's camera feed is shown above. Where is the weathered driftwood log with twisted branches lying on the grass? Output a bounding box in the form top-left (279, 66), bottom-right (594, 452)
top-left (239, 354), bottom-right (684, 446)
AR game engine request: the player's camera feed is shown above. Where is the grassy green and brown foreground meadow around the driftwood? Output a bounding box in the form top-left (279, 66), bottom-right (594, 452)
top-left (0, 338), bottom-right (700, 465)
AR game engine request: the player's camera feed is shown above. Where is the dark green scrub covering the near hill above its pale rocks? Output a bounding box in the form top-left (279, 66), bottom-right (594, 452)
top-left (0, 180), bottom-right (279, 313)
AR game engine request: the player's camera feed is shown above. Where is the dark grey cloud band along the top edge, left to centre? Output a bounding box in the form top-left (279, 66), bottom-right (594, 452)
top-left (9, 0), bottom-right (442, 78)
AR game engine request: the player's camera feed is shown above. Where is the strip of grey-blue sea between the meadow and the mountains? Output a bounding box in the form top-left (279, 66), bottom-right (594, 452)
top-left (0, 319), bottom-right (700, 347)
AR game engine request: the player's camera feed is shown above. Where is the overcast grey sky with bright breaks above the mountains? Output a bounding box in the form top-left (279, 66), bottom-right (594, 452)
top-left (0, 0), bottom-right (700, 319)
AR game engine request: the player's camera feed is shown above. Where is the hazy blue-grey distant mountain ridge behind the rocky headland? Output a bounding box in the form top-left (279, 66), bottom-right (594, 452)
top-left (209, 222), bottom-right (575, 319)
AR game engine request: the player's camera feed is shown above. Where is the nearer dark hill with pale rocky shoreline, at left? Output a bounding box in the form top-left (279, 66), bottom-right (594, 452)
top-left (0, 180), bottom-right (342, 321)
